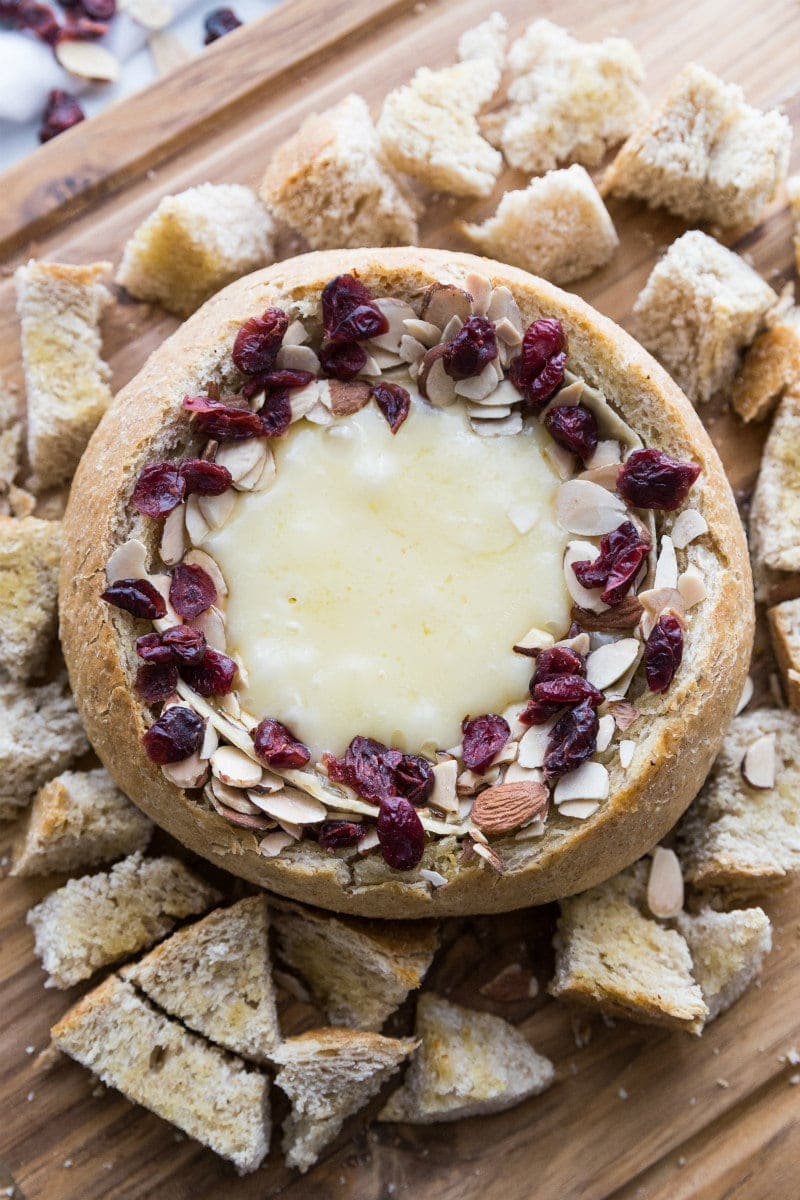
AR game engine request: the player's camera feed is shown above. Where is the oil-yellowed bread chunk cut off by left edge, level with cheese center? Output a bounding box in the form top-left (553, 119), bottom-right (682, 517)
top-left (0, 517), bottom-right (61, 683)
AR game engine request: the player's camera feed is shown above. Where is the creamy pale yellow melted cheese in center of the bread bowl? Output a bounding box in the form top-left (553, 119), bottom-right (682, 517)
top-left (204, 397), bottom-right (570, 755)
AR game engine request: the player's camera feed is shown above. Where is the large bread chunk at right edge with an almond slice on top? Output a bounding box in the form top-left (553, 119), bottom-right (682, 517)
top-left (676, 708), bottom-right (800, 896)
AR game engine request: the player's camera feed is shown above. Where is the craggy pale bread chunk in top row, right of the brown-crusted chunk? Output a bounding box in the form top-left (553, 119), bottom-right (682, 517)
top-left (378, 58), bottom-right (503, 196)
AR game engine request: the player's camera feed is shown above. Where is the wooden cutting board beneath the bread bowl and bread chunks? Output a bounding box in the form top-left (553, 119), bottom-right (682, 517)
top-left (0, 0), bottom-right (800, 1200)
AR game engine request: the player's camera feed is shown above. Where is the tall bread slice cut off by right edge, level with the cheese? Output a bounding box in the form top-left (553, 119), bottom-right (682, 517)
top-left (750, 389), bottom-right (800, 600)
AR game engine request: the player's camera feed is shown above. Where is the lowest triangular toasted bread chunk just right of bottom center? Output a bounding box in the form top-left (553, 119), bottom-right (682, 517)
top-left (378, 992), bottom-right (554, 1124)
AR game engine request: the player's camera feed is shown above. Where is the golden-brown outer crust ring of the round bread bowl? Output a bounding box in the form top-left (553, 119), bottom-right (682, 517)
top-left (60, 248), bottom-right (753, 918)
